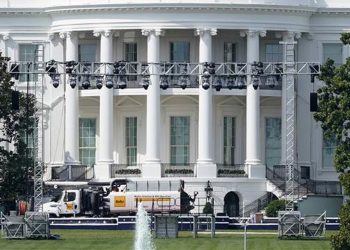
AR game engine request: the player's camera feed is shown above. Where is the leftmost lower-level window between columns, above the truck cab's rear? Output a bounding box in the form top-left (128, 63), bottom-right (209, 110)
top-left (79, 118), bottom-right (96, 166)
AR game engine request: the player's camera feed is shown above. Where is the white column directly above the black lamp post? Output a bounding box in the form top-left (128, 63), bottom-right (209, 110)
top-left (195, 29), bottom-right (217, 178)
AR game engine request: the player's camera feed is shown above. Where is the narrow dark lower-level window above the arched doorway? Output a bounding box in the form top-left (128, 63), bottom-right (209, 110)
top-left (223, 116), bottom-right (236, 166)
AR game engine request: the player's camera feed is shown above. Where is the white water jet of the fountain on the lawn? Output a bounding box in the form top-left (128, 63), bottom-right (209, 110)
top-left (134, 203), bottom-right (156, 250)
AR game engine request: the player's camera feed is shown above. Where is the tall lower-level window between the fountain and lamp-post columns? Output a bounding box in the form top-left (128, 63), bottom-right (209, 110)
top-left (170, 116), bottom-right (190, 166)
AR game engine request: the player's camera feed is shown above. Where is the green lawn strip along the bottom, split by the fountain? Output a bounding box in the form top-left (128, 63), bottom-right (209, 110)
top-left (0, 230), bottom-right (333, 250)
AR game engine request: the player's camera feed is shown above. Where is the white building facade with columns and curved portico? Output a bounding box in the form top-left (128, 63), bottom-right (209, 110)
top-left (0, 0), bottom-right (350, 216)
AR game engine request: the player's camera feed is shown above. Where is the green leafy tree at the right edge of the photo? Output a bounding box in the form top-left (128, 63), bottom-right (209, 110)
top-left (314, 33), bottom-right (350, 250)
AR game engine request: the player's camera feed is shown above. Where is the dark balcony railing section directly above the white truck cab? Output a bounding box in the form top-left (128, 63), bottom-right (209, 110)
top-left (51, 165), bottom-right (93, 181)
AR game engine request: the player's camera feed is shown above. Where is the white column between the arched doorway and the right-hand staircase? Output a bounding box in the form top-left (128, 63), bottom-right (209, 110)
top-left (245, 30), bottom-right (266, 178)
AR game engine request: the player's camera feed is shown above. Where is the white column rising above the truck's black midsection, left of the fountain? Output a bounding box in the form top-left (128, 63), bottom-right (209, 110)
top-left (94, 30), bottom-right (114, 179)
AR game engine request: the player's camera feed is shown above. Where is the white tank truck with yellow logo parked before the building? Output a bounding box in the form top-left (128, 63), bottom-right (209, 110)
top-left (43, 179), bottom-right (198, 217)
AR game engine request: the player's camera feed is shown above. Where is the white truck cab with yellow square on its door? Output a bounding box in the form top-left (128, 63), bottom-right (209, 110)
top-left (43, 190), bottom-right (81, 217)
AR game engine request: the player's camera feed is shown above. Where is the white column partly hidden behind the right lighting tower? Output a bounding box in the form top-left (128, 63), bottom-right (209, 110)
top-left (281, 32), bottom-right (300, 165)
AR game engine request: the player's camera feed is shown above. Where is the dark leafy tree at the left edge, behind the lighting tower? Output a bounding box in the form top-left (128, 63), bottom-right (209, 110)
top-left (0, 52), bottom-right (36, 211)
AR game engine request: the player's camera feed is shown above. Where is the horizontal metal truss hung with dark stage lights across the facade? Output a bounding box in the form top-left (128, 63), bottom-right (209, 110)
top-left (8, 60), bottom-right (320, 91)
